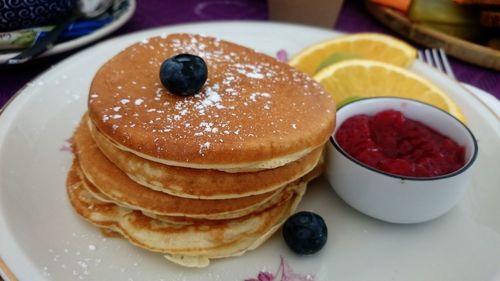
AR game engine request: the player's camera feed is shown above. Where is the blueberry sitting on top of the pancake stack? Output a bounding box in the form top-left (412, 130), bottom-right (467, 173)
top-left (160, 54), bottom-right (208, 96)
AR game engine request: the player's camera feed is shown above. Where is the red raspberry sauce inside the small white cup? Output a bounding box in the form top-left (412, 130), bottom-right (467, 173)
top-left (335, 110), bottom-right (465, 177)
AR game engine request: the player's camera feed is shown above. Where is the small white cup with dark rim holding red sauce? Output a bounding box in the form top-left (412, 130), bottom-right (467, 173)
top-left (326, 97), bottom-right (478, 223)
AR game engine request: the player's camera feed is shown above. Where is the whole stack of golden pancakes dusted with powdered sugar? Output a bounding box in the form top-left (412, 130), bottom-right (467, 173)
top-left (67, 34), bottom-right (335, 267)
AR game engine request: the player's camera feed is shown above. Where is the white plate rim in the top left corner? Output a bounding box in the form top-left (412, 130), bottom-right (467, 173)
top-left (0, 0), bottom-right (136, 64)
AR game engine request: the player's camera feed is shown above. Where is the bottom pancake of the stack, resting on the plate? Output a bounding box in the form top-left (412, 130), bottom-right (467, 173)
top-left (66, 161), bottom-right (306, 267)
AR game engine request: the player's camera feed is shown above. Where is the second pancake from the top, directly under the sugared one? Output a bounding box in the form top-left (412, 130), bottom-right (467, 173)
top-left (87, 114), bottom-right (323, 199)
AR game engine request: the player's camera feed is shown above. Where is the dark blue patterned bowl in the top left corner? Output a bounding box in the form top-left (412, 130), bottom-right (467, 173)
top-left (0, 0), bottom-right (78, 31)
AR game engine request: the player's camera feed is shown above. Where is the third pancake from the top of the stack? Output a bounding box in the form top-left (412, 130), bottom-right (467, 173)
top-left (73, 118), bottom-right (308, 219)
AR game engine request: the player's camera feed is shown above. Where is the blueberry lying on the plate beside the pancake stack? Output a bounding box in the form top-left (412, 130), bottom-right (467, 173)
top-left (283, 211), bottom-right (328, 255)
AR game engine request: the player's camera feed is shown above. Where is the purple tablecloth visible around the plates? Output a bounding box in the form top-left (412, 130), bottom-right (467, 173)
top-left (0, 0), bottom-right (500, 107)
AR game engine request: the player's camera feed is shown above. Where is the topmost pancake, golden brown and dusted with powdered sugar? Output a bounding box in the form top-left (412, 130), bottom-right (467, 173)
top-left (88, 34), bottom-right (335, 168)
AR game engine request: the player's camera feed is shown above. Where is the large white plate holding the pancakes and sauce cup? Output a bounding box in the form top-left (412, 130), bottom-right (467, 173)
top-left (0, 22), bottom-right (500, 281)
